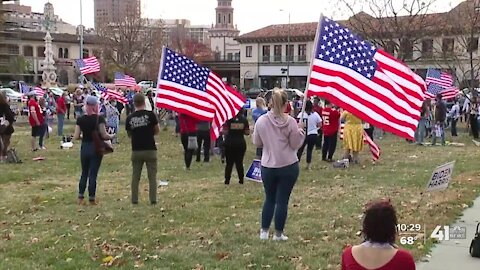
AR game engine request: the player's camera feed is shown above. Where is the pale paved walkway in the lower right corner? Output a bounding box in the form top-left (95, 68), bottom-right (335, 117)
top-left (417, 197), bottom-right (480, 270)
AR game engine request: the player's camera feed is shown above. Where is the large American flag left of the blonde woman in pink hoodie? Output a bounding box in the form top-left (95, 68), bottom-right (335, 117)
top-left (156, 48), bottom-right (245, 139)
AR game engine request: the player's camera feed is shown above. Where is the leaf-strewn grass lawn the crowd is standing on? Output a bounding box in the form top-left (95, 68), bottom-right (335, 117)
top-left (0, 119), bottom-right (480, 269)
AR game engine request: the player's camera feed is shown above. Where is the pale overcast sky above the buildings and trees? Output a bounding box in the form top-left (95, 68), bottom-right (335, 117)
top-left (20, 0), bottom-right (462, 34)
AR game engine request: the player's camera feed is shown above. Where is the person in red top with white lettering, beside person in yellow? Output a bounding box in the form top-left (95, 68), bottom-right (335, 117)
top-left (322, 100), bottom-right (340, 162)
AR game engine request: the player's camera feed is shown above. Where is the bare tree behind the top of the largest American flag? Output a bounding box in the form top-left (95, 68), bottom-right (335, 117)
top-left (338, 0), bottom-right (437, 61)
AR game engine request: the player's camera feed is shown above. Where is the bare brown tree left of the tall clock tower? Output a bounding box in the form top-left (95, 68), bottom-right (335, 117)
top-left (98, 14), bottom-right (163, 79)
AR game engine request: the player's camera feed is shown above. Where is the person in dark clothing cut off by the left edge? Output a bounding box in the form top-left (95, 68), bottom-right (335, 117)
top-left (0, 93), bottom-right (15, 163)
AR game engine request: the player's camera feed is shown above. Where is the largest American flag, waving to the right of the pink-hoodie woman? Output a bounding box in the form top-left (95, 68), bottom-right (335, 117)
top-left (307, 18), bottom-right (426, 139)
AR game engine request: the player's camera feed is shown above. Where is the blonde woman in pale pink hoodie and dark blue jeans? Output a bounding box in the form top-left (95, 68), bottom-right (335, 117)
top-left (252, 90), bottom-right (305, 241)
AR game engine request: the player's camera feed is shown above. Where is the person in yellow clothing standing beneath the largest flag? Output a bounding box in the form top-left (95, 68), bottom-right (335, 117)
top-left (340, 111), bottom-right (363, 164)
